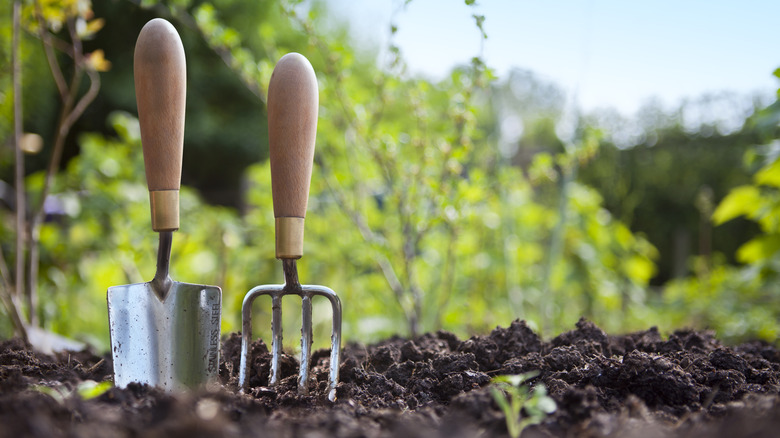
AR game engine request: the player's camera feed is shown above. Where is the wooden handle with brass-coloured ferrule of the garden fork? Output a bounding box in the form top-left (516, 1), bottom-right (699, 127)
top-left (268, 53), bottom-right (319, 259)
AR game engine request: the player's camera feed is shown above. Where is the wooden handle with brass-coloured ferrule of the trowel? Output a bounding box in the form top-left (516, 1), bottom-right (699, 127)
top-left (133, 18), bottom-right (187, 231)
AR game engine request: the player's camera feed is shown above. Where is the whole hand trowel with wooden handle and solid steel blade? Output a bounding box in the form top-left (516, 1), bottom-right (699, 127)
top-left (108, 18), bottom-right (222, 391)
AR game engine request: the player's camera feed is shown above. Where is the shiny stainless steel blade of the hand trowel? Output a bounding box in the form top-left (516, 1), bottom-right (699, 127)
top-left (107, 281), bottom-right (222, 391)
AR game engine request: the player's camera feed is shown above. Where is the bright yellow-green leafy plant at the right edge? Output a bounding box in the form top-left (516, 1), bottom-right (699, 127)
top-left (648, 70), bottom-right (780, 342)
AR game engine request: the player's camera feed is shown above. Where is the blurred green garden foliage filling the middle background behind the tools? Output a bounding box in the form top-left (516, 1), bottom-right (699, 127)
top-left (0, 0), bottom-right (780, 348)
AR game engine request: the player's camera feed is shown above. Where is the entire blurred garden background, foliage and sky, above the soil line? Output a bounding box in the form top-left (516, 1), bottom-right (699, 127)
top-left (0, 0), bottom-right (780, 349)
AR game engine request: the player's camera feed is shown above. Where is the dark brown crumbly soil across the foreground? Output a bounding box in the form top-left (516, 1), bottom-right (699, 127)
top-left (0, 320), bottom-right (780, 438)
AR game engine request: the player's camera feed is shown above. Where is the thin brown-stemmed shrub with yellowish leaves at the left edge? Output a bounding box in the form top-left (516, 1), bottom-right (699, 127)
top-left (0, 0), bottom-right (111, 338)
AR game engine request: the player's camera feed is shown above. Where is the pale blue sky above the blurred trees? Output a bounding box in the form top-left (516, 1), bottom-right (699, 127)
top-left (328, 0), bottom-right (780, 115)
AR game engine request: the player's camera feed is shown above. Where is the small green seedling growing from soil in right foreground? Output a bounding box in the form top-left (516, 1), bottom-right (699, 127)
top-left (490, 371), bottom-right (556, 438)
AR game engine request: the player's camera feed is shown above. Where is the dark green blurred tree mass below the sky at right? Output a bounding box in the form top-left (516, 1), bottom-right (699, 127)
top-left (580, 99), bottom-right (759, 285)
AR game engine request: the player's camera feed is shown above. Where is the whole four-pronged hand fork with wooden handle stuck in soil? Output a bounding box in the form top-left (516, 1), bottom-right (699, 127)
top-left (239, 53), bottom-right (341, 401)
